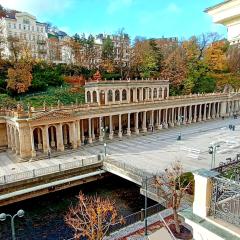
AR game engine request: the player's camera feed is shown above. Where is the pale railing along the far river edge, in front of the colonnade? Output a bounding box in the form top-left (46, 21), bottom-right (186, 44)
top-left (0, 157), bottom-right (101, 185)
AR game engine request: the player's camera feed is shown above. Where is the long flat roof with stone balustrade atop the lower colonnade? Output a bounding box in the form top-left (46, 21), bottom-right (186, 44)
top-left (0, 93), bottom-right (234, 120)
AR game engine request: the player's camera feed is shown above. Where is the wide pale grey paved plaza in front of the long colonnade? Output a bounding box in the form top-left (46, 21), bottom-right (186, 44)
top-left (0, 118), bottom-right (240, 175)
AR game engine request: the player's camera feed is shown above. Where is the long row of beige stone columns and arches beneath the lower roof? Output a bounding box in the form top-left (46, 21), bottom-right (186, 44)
top-left (7, 98), bottom-right (240, 156)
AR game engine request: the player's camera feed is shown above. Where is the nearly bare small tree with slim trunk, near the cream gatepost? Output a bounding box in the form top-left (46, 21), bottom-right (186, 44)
top-left (155, 161), bottom-right (191, 233)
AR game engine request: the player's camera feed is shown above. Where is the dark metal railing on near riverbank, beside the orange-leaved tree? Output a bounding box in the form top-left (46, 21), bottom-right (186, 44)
top-left (108, 203), bottom-right (164, 234)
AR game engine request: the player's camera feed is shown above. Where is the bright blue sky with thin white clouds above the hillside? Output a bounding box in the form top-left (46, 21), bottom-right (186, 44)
top-left (0, 0), bottom-right (226, 39)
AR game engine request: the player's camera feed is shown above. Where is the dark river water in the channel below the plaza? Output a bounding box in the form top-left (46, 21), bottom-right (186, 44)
top-left (0, 176), bottom-right (155, 240)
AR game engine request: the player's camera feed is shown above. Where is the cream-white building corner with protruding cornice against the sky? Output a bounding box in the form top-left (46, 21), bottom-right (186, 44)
top-left (205, 0), bottom-right (240, 44)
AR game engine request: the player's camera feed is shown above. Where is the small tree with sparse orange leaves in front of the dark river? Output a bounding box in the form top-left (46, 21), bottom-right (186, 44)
top-left (65, 192), bottom-right (122, 240)
